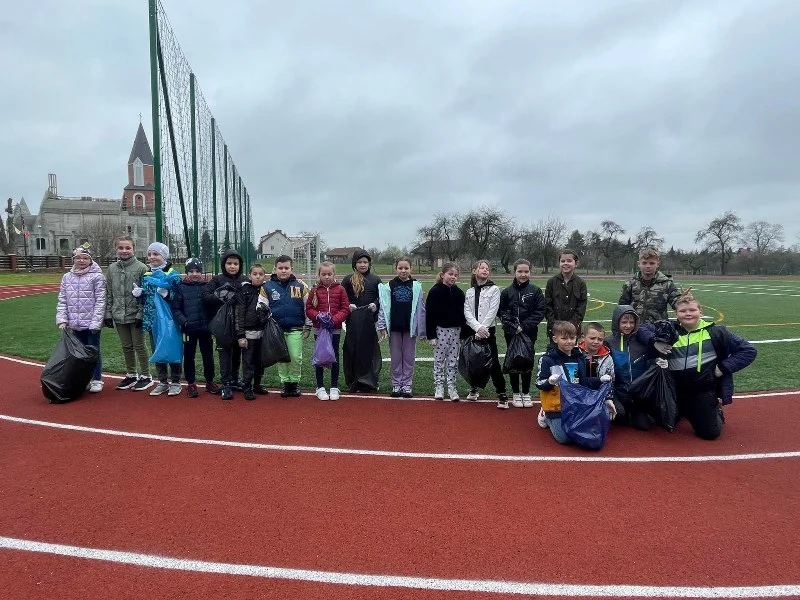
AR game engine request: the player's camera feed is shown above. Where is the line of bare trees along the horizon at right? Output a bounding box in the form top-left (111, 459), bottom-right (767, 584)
top-left (406, 206), bottom-right (800, 275)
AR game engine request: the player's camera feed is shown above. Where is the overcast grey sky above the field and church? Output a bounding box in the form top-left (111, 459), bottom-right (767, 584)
top-left (0, 0), bottom-right (800, 248)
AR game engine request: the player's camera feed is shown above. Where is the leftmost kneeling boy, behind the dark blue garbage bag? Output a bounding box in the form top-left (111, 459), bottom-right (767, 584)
top-left (536, 321), bottom-right (617, 444)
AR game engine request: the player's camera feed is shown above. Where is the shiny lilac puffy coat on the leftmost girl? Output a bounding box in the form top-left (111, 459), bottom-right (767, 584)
top-left (56, 261), bottom-right (106, 331)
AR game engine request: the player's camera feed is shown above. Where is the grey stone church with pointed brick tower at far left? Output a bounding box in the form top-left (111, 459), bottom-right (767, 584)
top-left (5, 123), bottom-right (155, 259)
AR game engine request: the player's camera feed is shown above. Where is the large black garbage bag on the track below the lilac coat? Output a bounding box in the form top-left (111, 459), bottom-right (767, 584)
top-left (41, 329), bottom-right (100, 404)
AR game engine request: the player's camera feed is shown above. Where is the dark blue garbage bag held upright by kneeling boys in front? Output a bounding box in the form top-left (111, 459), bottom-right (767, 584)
top-left (558, 380), bottom-right (611, 450)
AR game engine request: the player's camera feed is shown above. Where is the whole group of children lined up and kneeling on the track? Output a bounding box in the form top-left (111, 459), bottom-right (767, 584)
top-left (56, 241), bottom-right (755, 443)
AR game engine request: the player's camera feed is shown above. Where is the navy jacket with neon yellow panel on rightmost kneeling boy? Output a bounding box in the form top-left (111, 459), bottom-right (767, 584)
top-left (648, 319), bottom-right (757, 404)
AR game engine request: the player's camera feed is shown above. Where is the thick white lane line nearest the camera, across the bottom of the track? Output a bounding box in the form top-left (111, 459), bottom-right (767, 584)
top-left (0, 537), bottom-right (800, 598)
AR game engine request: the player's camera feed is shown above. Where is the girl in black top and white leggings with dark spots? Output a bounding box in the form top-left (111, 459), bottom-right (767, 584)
top-left (425, 263), bottom-right (466, 402)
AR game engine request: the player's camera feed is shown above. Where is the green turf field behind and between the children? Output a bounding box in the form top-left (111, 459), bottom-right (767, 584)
top-left (0, 276), bottom-right (800, 394)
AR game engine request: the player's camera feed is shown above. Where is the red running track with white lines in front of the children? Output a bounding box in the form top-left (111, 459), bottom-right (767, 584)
top-left (0, 284), bottom-right (800, 599)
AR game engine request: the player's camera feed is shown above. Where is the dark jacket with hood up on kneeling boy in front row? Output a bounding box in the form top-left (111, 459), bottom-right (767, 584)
top-left (607, 304), bottom-right (650, 402)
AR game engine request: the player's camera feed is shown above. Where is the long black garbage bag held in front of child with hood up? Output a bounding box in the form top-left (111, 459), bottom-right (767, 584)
top-left (342, 306), bottom-right (383, 392)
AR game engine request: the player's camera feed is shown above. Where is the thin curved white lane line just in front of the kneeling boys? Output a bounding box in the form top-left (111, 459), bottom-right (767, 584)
top-left (0, 415), bottom-right (800, 463)
